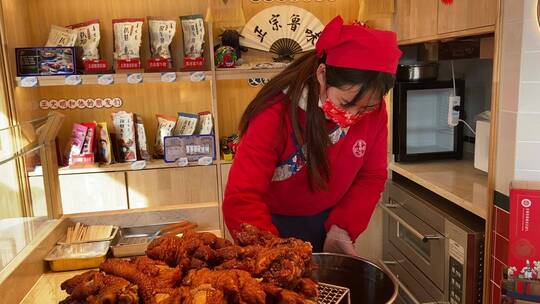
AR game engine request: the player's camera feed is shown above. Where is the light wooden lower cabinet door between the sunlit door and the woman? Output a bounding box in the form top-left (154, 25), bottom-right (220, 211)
top-left (126, 165), bottom-right (218, 208)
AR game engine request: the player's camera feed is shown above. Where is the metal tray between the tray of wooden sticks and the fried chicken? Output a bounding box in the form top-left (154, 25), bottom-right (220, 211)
top-left (111, 223), bottom-right (174, 258)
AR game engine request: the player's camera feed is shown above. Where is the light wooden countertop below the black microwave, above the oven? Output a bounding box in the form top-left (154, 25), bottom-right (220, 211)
top-left (390, 160), bottom-right (489, 219)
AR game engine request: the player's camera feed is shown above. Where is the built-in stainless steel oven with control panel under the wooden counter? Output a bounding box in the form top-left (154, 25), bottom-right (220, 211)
top-left (382, 174), bottom-right (484, 304)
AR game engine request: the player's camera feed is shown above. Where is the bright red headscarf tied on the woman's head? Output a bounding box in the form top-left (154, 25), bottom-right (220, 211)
top-left (315, 16), bottom-right (401, 74)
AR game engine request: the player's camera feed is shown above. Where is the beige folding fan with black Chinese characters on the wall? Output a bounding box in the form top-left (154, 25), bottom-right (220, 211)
top-left (240, 5), bottom-right (324, 61)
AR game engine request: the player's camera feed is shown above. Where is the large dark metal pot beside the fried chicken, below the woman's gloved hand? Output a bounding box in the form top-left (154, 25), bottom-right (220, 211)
top-left (313, 253), bottom-right (398, 304)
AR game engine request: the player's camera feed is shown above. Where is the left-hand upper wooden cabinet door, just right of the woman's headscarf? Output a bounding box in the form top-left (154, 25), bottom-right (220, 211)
top-left (396, 0), bottom-right (439, 40)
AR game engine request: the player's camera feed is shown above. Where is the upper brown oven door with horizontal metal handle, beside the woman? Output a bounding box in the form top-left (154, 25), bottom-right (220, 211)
top-left (382, 203), bottom-right (446, 291)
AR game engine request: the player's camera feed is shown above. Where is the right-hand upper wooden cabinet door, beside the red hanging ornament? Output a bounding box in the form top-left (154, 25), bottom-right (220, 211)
top-left (437, 0), bottom-right (497, 34)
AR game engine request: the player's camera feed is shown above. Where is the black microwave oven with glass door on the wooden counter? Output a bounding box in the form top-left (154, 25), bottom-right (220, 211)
top-left (392, 79), bottom-right (465, 162)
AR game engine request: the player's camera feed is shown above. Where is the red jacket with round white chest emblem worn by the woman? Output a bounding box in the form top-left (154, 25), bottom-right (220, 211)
top-left (223, 94), bottom-right (388, 240)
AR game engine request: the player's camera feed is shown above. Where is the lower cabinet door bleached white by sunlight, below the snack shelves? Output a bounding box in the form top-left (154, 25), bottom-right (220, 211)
top-left (59, 172), bottom-right (128, 214)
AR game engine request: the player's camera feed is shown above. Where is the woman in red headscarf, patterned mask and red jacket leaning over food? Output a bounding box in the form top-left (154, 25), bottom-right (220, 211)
top-left (223, 17), bottom-right (401, 255)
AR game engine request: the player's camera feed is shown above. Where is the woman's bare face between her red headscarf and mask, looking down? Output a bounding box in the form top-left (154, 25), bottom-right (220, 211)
top-left (317, 64), bottom-right (381, 115)
